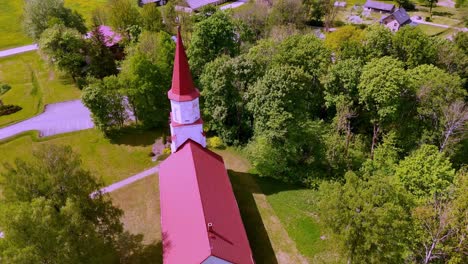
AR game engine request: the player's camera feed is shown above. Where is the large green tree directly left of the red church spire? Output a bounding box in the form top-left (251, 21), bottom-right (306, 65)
top-left (119, 32), bottom-right (175, 128)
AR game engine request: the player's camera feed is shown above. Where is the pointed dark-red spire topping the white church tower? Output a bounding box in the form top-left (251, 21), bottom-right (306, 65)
top-left (167, 27), bottom-right (200, 102)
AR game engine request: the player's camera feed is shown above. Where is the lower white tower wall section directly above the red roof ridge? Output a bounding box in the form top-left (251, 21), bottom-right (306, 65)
top-left (171, 124), bottom-right (206, 153)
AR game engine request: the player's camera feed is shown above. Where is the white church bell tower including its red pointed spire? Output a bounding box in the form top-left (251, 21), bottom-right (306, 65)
top-left (167, 29), bottom-right (206, 153)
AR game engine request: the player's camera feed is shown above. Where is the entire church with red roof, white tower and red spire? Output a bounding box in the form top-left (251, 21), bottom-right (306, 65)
top-left (159, 27), bottom-right (254, 264)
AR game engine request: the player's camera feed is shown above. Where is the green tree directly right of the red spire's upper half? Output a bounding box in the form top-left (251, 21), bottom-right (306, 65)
top-left (187, 11), bottom-right (239, 76)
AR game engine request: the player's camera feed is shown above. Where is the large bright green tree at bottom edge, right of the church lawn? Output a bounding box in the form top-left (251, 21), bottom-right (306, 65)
top-left (318, 172), bottom-right (412, 263)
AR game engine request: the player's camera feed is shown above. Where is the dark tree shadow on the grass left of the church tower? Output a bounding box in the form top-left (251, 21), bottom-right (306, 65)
top-left (106, 126), bottom-right (162, 146)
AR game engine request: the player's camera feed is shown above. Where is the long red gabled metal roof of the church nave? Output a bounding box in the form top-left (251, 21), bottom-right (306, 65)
top-left (159, 140), bottom-right (253, 264)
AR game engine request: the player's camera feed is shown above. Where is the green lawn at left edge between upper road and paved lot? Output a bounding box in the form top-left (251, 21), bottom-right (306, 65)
top-left (0, 51), bottom-right (81, 127)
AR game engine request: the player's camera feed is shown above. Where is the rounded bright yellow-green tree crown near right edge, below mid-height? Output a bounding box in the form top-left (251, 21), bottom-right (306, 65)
top-left (395, 145), bottom-right (455, 199)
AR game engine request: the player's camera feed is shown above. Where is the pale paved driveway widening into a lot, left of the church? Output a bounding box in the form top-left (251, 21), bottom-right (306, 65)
top-left (0, 100), bottom-right (94, 140)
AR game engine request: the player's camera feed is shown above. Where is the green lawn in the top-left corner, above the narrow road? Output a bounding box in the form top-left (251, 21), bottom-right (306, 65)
top-left (0, 0), bottom-right (33, 50)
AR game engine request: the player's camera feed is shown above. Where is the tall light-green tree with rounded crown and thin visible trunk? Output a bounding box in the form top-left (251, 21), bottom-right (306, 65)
top-left (358, 57), bottom-right (410, 158)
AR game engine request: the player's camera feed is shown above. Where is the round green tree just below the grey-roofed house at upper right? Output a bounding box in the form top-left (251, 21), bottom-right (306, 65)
top-left (393, 27), bottom-right (437, 68)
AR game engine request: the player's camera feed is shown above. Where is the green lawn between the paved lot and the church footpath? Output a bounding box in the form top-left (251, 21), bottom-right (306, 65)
top-left (0, 129), bottom-right (159, 184)
